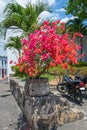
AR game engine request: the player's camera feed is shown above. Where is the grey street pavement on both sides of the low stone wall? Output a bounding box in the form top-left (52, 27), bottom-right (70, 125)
top-left (0, 79), bottom-right (87, 130)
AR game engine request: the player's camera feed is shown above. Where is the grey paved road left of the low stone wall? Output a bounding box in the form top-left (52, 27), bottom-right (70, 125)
top-left (0, 80), bottom-right (29, 130)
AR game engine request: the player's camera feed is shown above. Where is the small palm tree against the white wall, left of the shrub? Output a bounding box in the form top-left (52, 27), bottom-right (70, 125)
top-left (4, 36), bottom-right (22, 57)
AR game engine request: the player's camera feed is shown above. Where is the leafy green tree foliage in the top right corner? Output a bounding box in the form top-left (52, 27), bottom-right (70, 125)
top-left (65, 0), bottom-right (87, 20)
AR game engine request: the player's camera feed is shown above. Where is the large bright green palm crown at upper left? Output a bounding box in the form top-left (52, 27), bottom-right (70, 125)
top-left (0, 2), bottom-right (48, 35)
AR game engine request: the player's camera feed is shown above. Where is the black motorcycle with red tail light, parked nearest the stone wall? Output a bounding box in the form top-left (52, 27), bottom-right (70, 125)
top-left (57, 75), bottom-right (85, 103)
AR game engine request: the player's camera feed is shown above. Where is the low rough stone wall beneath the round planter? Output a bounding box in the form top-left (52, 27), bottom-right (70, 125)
top-left (10, 78), bottom-right (84, 130)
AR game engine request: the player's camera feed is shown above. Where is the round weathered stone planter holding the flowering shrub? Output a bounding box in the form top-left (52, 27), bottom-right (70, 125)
top-left (25, 78), bottom-right (49, 96)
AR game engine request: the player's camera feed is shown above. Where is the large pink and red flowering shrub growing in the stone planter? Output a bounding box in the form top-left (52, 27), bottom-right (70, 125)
top-left (16, 21), bottom-right (81, 77)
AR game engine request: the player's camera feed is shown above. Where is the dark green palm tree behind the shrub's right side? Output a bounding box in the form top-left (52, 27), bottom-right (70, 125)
top-left (66, 18), bottom-right (87, 54)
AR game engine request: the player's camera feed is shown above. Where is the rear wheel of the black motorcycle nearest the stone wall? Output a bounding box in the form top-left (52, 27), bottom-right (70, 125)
top-left (74, 89), bottom-right (83, 103)
